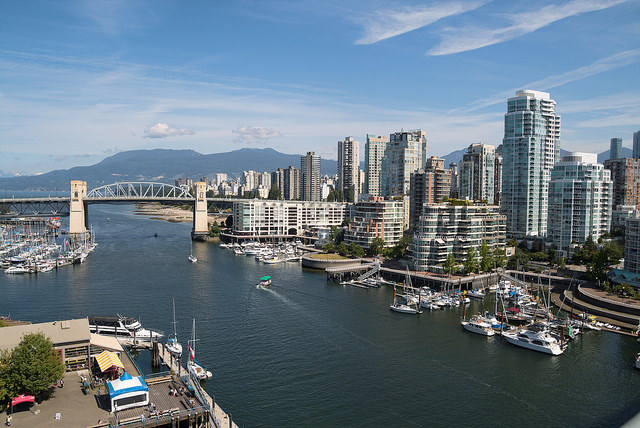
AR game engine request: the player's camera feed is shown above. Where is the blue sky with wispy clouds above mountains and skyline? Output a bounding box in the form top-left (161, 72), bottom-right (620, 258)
top-left (0, 0), bottom-right (640, 175)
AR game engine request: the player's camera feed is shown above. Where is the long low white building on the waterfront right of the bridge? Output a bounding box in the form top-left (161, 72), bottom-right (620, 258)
top-left (233, 200), bottom-right (347, 236)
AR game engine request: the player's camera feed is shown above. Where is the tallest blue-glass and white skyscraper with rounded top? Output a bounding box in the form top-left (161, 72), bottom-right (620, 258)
top-left (500, 90), bottom-right (560, 238)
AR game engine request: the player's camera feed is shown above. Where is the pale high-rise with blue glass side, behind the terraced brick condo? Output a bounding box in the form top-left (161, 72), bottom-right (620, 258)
top-left (380, 129), bottom-right (427, 196)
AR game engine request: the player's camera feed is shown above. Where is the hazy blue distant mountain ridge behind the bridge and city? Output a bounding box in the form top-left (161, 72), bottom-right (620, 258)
top-left (0, 148), bottom-right (337, 190)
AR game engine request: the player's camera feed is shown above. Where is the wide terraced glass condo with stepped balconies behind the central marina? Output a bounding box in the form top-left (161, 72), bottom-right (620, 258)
top-left (411, 203), bottom-right (506, 273)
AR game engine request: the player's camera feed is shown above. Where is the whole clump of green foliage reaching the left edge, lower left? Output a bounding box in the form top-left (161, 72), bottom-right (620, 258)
top-left (0, 332), bottom-right (65, 410)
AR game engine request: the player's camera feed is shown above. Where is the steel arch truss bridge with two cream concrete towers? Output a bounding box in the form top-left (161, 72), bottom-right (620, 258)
top-left (0, 180), bottom-right (215, 239)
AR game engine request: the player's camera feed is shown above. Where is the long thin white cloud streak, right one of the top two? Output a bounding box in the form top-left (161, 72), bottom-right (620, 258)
top-left (427, 0), bottom-right (626, 55)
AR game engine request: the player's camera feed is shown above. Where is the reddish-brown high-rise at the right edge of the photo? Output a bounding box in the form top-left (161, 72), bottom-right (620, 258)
top-left (604, 158), bottom-right (640, 209)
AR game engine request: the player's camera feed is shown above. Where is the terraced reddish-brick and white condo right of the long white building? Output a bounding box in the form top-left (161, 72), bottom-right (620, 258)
top-left (344, 196), bottom-right (404, 249)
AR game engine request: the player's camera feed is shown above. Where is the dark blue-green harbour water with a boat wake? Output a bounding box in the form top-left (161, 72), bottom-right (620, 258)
top-left (0, 205), bottom-right (640, 427)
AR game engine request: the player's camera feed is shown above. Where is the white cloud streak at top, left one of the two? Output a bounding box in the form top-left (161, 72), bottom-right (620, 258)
top-left (355, 0), bottom-right (487, 45)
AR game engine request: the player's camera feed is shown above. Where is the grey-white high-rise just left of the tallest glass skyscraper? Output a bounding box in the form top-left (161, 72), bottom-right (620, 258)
top-left (458, 144), bottom-right (496, 203)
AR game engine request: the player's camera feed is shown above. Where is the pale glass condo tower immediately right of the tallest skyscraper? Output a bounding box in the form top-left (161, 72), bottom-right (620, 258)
top-left (547, 153), bottom-right (613, 255)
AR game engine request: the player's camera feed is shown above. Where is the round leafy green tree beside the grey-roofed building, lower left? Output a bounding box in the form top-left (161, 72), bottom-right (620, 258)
top-left (9, 333), bottom-right (64, 395)
